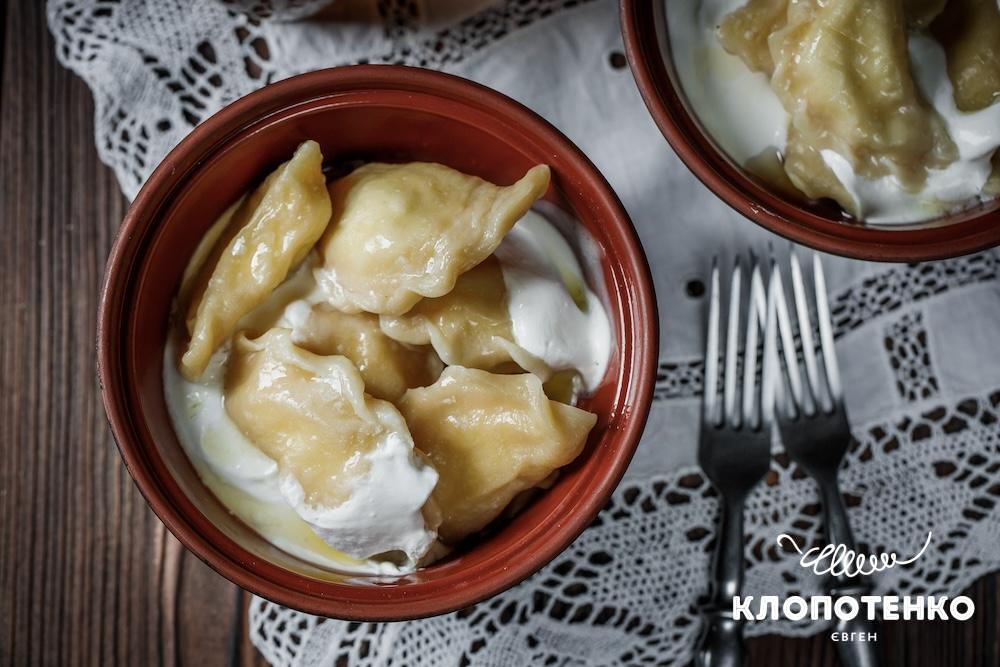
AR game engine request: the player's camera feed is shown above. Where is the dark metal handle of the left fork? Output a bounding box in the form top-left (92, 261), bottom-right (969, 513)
top-left (697, 498), bottom-right (744, 667)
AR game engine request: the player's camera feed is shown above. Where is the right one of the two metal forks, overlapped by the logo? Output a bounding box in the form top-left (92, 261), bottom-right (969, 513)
top-left (771, 251), bottom-right (881, 667)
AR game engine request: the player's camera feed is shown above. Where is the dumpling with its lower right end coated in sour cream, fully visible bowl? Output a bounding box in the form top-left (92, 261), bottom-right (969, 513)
top-left (225, 329), bottom-right (437, 564)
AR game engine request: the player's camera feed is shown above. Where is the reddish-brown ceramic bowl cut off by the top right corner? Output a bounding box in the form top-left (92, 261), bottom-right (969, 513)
top-left (621, 0), bottom-right (1000, 261)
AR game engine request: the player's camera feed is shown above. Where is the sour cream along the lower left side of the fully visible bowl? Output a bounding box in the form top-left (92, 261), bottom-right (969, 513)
top-left (163, 337), bottom-right (437, 575)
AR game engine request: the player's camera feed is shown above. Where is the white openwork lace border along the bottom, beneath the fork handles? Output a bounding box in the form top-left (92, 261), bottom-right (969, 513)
top-left (250, 389), bottom-right (1000, 665)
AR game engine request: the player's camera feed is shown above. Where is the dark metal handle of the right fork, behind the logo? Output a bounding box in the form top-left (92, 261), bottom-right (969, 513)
top-left (817, 476), bottom-right (882, 667)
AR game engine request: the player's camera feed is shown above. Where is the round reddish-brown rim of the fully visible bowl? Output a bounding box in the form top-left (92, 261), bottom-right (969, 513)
top-left (97, 65), bottom-right (659, 621)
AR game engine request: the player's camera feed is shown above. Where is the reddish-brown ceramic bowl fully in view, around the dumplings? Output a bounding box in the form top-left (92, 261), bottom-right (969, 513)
top-left (98, 66), bottom-right (658, 620)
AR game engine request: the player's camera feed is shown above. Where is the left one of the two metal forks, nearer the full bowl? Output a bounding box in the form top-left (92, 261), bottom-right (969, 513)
top-left (698, 260), bottom-right (777, 667)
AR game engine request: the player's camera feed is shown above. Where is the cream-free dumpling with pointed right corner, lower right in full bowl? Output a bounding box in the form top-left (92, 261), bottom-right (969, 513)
top-left (399, 366), bottom-right (597, 544)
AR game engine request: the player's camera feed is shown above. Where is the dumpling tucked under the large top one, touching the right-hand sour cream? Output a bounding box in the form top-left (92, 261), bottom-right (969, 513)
top-left (381, 256), bottom-right (549, 377)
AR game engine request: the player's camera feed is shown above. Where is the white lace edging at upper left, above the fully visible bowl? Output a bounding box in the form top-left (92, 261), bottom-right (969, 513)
top-left (48, 0), bottom-right (591, 199)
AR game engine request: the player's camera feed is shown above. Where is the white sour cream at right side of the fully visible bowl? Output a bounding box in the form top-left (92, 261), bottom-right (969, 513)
top-left (495, 211), bottom-right (612, 391)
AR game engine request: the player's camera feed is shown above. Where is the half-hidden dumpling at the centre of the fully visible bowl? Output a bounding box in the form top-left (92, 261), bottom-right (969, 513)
top-left (294, 304), bottom-right (442, 401)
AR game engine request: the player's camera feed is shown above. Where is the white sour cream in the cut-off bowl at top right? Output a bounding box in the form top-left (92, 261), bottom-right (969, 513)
top-left (666, 0), bottom-right (1000, 225)
